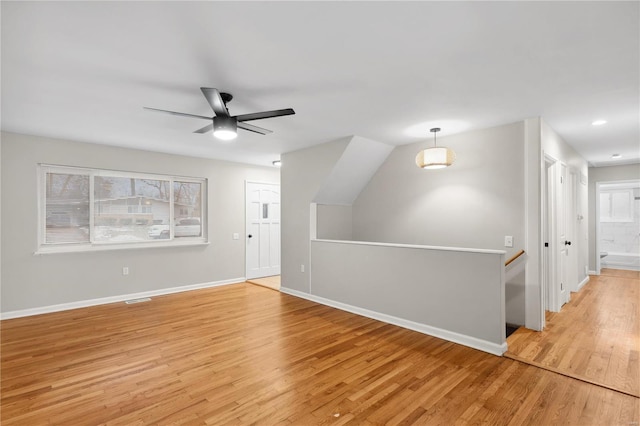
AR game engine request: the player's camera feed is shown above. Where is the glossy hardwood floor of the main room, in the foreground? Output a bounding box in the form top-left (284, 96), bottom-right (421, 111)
top-left (0, 284), bottom-right (640, 426)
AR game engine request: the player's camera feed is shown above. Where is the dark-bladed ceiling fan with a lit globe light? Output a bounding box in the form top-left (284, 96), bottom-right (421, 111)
top-left (143, 87), bottom-right (296, 140)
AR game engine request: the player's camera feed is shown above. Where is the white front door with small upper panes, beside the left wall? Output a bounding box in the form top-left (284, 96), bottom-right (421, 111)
top-left (245, 182), bottom-right (280, 279)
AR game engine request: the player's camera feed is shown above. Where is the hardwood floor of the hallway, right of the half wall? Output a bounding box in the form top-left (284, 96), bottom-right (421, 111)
top-left (506, 269), bottom-right (640, 396)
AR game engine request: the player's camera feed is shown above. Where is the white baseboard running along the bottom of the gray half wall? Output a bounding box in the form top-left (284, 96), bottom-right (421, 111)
top-left (280, 287), bottom-right (507, 356)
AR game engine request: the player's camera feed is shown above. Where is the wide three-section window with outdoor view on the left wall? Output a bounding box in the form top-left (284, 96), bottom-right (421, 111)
top-left (40, 165), bottom-right (206, 251)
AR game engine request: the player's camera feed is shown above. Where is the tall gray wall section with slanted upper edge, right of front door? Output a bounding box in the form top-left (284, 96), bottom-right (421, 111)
top-left (280, 137), bottom-right (351, 293)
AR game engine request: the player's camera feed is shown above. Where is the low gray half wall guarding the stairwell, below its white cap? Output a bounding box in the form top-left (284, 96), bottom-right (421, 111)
top-left (311, 241), bottom-right (505, 355)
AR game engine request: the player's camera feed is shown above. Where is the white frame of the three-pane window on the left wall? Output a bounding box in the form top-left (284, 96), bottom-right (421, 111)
top-left (35, 164), bottom-right (209, 254)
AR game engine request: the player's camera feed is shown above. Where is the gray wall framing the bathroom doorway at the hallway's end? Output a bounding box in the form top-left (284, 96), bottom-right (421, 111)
top-left (589, 164), bottom-right (640, 272)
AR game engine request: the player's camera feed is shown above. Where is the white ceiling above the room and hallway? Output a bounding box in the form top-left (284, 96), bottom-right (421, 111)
top-left (0, 1), bottom-right (640, 165)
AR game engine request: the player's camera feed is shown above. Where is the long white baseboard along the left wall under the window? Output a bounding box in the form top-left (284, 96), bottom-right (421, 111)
top-left (0, 277), bottom-right (246, 320)
